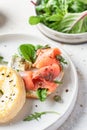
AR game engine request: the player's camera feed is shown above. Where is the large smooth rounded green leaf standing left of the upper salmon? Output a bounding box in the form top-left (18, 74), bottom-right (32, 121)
top-left (18, 44), bottom-right (36, 62)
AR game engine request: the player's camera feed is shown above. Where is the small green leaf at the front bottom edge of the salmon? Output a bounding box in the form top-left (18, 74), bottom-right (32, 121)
top-left (37, 88), bottom-right (48, 102)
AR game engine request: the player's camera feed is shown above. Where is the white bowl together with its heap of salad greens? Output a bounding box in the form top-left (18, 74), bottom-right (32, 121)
top-left (29, 0), bottom-right (87, 44)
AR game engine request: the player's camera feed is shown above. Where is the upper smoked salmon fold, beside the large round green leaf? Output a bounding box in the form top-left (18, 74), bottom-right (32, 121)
top-left (33, 48), bottom-right (61, 68)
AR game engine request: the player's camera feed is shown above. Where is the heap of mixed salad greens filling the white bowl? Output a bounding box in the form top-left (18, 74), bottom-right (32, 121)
top-left (29, 0), bottom-right (87, 33)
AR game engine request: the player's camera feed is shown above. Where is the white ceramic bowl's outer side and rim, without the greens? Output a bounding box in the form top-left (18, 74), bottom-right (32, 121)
top-left (37, 23), bottom-right (87, 44)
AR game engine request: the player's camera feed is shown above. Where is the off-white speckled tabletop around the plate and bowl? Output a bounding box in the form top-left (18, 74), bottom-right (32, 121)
top-left (0, 0), bottom-right (87, 130)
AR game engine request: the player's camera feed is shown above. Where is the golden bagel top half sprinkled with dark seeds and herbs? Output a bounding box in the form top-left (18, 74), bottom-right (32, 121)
top-left (0, 66), bottom-right (26, 123)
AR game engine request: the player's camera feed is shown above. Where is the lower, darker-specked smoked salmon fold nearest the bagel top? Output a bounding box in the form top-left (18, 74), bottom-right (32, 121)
top-left (22, 64), bottom-right (61, 92)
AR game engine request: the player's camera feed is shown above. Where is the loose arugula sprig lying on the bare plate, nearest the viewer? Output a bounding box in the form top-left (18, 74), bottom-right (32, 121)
top-left (24, 111), bottom-right (59, 121)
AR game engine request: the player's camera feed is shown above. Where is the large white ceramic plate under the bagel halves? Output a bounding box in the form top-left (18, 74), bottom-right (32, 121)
top-left (0, 34), bottom-right (78, 130)
